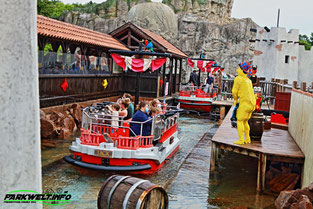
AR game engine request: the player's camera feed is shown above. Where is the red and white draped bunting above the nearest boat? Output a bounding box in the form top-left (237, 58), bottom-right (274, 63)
top-left (111, 54), bottom-right (166, 73)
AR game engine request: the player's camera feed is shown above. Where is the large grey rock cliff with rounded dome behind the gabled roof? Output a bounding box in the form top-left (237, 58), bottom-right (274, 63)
top-left (61, 0), bottom-right (256, 75)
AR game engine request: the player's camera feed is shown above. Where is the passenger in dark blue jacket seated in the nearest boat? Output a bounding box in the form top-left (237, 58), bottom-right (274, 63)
top-left (130, 101), bottom-right (152, 136)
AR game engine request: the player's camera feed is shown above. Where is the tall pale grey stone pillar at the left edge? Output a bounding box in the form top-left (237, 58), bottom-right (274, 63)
top-left (0, 0), bottom-right (42, 208)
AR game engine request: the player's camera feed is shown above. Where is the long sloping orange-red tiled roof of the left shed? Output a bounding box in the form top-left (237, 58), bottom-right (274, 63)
top-left (37, 15), bottom-right (129, 50)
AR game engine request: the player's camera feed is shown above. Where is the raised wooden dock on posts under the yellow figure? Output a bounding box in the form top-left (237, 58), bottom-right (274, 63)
top-left (210, 107), bottom-right (304, 192)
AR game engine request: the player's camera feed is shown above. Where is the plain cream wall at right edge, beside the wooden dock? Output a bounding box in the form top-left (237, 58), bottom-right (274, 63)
top-left (288, 90), bottom-right (313, 187)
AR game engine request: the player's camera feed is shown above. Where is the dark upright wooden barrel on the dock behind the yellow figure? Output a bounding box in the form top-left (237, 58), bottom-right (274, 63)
top-left (249, 112), bottom-right (264, 141)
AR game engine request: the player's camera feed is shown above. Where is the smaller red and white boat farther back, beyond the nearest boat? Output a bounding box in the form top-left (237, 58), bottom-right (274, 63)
top-left (176, 86), bottom-right (217, 112)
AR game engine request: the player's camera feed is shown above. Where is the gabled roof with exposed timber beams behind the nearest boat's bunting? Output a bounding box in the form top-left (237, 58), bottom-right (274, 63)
top-left (110, 22), bottom-right (188, 58)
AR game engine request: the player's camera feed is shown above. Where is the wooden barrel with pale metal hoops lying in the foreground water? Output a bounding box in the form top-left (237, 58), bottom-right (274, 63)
top-left (98, 175), bottom-right (168, 209)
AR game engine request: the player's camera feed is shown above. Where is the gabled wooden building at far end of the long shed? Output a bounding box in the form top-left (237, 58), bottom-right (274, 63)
top-left (110, 22), bottom-right (188, 97)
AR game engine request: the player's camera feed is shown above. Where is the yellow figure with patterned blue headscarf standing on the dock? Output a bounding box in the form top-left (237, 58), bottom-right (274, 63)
top-left (232, 62), bottom-right (256, 145)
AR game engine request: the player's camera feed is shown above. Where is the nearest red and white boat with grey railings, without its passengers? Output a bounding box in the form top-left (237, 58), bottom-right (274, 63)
top-left (64, 104), bottom-right (181, 174)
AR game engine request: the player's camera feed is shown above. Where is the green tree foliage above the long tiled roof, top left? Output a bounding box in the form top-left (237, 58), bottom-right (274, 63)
top-left (37, 0), bottom-right (75, 19)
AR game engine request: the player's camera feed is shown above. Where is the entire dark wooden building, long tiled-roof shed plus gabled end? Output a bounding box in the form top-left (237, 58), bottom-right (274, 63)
top-left (37, 15), bottom-right (187, 107)
